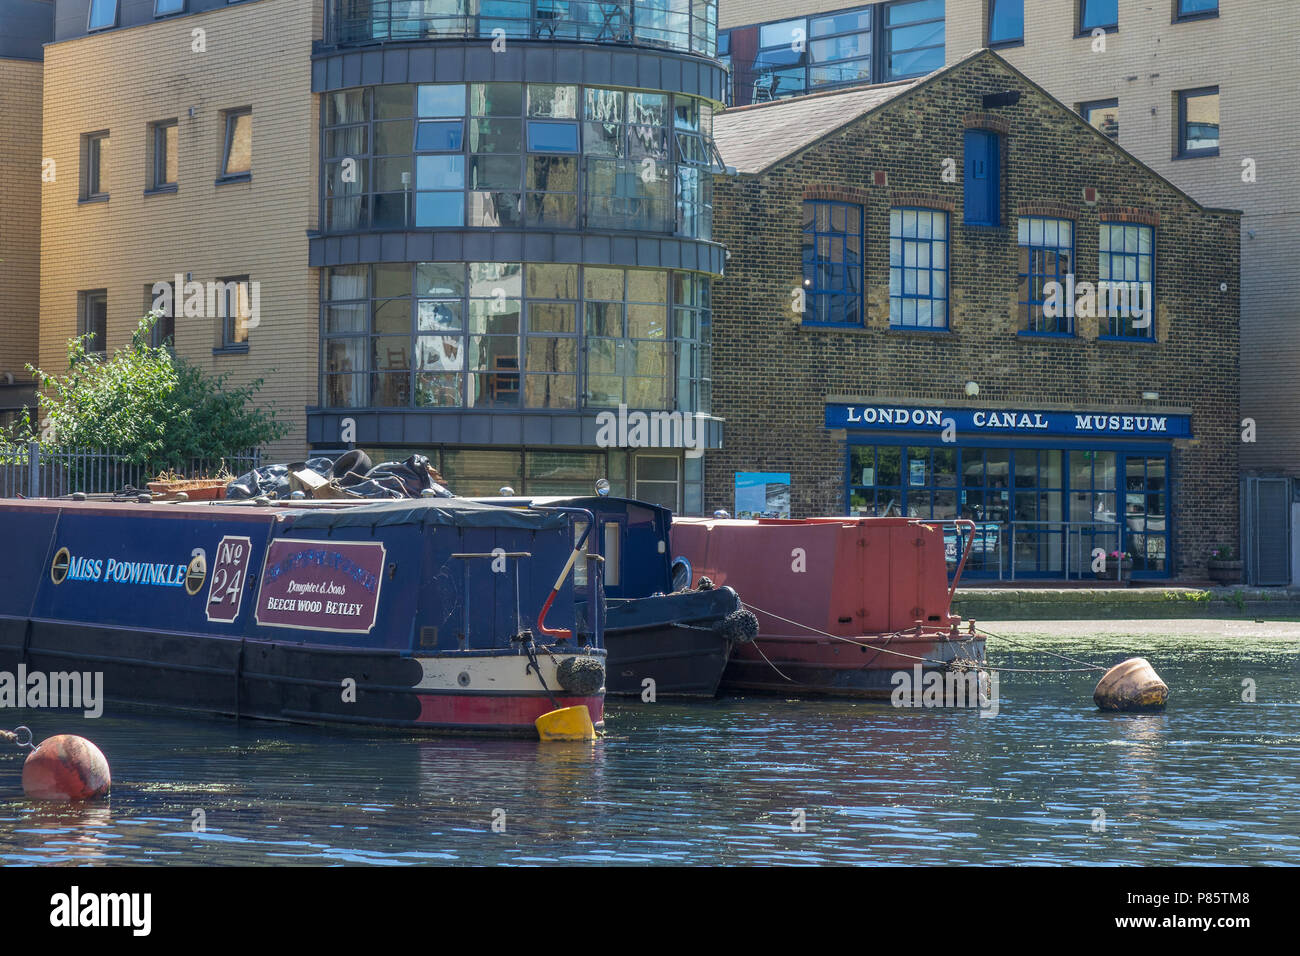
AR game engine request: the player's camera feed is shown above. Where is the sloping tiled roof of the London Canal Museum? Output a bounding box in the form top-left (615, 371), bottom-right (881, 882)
top-left (714, 77), bottom-right (926, 173)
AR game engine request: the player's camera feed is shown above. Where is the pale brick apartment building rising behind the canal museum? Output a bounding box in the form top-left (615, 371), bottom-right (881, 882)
top-left (719, 0), bottom-right (1300, 584)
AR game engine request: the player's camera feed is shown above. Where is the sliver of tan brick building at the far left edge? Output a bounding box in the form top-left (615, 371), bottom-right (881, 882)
top-left (0, 0), bottom-right (55, 427)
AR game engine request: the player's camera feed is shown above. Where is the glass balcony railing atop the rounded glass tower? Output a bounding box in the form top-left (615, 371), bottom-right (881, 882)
top-left (326, 0), bottom-right (718, 57)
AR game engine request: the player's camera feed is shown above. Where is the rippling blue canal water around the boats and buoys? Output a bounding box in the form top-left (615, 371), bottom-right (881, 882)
top-left (0, 620), bottom-right (1300, 865)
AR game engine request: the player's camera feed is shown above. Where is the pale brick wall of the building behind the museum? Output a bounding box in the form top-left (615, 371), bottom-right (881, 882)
top-left (946, 0), bottom-right (1300, 475)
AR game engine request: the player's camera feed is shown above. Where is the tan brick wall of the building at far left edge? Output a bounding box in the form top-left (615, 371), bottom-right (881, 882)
top-left (0, 60), bottom-right (42, 381)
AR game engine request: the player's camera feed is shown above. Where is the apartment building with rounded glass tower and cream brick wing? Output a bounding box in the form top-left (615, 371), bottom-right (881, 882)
top-left (40, 0), bottom-right (725, 512)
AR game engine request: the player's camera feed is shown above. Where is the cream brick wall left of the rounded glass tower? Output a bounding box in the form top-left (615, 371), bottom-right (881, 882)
top-left (40, 0), bottom-right (321, 459)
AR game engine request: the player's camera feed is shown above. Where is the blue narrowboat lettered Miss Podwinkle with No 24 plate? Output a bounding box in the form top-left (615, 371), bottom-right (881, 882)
top-left (0, 498), bottom-right (605, 735)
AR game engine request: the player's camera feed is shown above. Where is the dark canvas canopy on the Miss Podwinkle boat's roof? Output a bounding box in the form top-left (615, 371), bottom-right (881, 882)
top-left (293, 498), bottom-right (569, 531)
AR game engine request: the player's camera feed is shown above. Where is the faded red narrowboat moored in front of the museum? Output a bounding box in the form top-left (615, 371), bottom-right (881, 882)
top-left (672, 518), bottom-right (984, 698)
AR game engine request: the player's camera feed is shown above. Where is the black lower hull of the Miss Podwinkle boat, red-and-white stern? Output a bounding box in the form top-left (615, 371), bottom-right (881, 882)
top-left (0, 618), bottom-right (603, 736)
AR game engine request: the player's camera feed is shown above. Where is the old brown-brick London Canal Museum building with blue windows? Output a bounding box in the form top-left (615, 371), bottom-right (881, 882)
top-left (705, 51), bottom-right (1240, 579)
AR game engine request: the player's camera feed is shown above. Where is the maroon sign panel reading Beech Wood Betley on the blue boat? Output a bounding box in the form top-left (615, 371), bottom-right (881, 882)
top-left (250, 538), bottom-right (385, 633)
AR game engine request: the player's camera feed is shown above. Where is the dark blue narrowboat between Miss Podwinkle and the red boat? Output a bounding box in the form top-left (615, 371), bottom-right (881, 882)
top-left (478, 496), bottom-right (758, 701)
